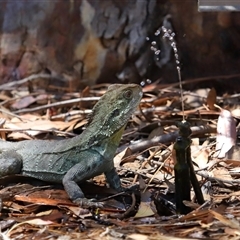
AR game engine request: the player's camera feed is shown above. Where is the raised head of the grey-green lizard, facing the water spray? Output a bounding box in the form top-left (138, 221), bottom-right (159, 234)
top-left (88, 84), bottom-right (142, 136)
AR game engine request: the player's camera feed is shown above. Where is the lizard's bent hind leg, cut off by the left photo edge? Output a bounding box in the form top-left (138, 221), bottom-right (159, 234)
top-left (0, 150), bottom-right (22, 177)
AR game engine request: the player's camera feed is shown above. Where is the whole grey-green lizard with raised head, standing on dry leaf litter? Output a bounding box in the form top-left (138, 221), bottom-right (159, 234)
top-left (0, 84), bottom-right (142, 207)
